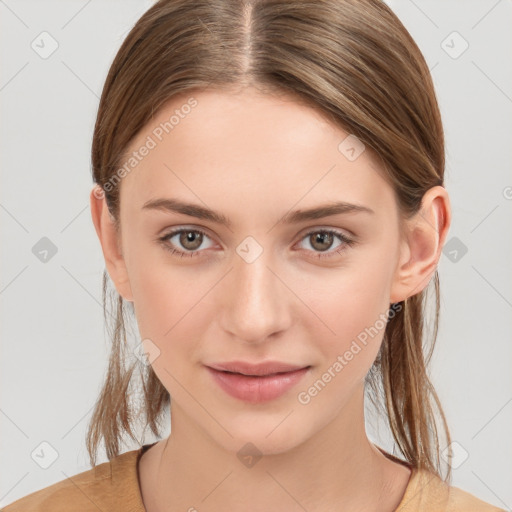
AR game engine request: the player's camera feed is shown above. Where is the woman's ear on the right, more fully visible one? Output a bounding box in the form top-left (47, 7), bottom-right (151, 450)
top-left (390, 185), bottom-right (451, 303)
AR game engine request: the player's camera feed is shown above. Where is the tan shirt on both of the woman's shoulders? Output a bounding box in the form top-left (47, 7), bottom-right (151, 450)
top-left (2, 443), bottom-right (505, 512)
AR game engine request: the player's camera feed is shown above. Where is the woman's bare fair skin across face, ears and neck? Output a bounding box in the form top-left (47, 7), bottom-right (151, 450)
top-left (90, 88), bottom-right (451, 512)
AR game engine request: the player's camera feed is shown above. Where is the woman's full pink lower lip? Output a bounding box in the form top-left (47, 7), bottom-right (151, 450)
top-left (206, 366), bottom-right (310, 403)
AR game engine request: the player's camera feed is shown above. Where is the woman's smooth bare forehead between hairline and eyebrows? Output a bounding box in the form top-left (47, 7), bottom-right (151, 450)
top-left (121, 89), bottom-right (394, 218)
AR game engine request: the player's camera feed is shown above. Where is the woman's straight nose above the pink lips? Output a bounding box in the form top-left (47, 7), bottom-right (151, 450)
top-left (220, 251), bottom-right (294, 344)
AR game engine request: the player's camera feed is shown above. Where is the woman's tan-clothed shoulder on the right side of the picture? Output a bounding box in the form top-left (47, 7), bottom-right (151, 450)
top-left (396, 469), bottom-right (505, 512)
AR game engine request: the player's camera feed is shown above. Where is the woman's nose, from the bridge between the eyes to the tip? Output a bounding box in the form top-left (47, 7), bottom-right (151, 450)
top-left (224, 244), bottom-right (290, 341)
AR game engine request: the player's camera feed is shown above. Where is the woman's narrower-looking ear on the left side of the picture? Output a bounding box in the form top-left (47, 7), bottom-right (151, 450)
top-left (90, 185), bottom-right (133, 302)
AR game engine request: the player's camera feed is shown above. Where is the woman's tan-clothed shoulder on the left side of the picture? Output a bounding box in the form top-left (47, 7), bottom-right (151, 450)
top-left (2, 449), bottom-right (144, 512)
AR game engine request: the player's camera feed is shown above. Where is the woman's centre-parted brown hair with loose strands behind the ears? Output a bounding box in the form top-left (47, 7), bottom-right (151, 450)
top-left (87, 0), bottom-right (451, 481)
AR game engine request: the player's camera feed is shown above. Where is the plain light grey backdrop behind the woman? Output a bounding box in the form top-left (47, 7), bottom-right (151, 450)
top-left (0, 0), bottom-right (512, 510)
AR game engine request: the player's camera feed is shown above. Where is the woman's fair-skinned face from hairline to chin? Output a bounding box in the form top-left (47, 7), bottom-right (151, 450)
top-left (102, 89), bottom-right (410, 453)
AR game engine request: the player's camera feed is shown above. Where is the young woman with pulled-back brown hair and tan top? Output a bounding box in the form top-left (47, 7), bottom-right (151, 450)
top-left (5, 0), bottom-right (500, 512)
